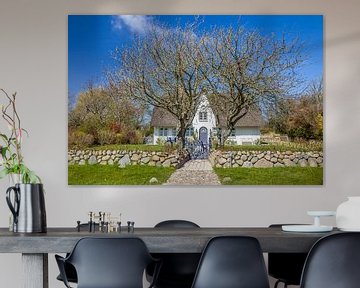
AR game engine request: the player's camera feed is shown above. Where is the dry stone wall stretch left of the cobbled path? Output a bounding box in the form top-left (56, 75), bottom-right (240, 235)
top-left (68, 150), bottom-right (184, 168)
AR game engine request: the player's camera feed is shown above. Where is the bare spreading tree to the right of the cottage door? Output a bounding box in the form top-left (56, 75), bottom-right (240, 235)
top-left (202, 26), bottom-right (304, 144)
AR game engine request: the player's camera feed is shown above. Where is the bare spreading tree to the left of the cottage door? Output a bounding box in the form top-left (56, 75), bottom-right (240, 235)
top-left (109, 23), bottom-right (205, 146)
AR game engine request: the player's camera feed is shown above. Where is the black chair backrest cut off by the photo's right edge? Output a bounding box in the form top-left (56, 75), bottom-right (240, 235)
top-left (300, 232), bottom-right (360, 288)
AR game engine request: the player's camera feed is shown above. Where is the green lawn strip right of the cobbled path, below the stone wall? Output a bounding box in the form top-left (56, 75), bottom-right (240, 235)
top-left (214, 167), bottom-right (323, 185)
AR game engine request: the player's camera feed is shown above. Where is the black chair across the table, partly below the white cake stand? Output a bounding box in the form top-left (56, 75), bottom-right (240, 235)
top-left (268, 224), bottom-right (307, 288)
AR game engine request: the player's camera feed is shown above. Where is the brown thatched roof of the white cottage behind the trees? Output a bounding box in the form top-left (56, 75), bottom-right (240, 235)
top-left (150, 107), bottom-right (263, 127)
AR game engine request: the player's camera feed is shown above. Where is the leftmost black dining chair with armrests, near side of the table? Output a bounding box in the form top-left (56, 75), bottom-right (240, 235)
top-left (55, 237), bottom-right (160, 288)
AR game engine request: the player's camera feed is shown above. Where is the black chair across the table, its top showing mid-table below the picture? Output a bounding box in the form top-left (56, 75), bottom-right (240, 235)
top-left (147, 220), bottom-right (201, 288)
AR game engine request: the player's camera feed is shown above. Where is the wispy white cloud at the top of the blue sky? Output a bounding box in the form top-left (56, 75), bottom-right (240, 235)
top-left (111, 15), bottom-right (152, 34)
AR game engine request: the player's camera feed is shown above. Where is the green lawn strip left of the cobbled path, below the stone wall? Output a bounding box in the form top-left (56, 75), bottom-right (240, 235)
top-left (68, 165), bottom-right (175, 185)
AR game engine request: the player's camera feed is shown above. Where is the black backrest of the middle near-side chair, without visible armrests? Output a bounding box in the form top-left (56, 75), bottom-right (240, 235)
top-left (192, 236), bottom-right (269, 288)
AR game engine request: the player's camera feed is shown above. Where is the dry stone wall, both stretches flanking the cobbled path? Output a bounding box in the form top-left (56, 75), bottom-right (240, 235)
top-left (68, 150), bottom-right (323, 168)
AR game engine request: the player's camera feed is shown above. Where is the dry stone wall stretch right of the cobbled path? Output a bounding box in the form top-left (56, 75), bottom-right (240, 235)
top-left (209, 151), bottom-right (323, 168)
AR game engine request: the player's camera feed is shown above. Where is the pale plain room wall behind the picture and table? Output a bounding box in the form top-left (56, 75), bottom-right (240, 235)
top-left (0, 0), bottom-right (360, 287)
